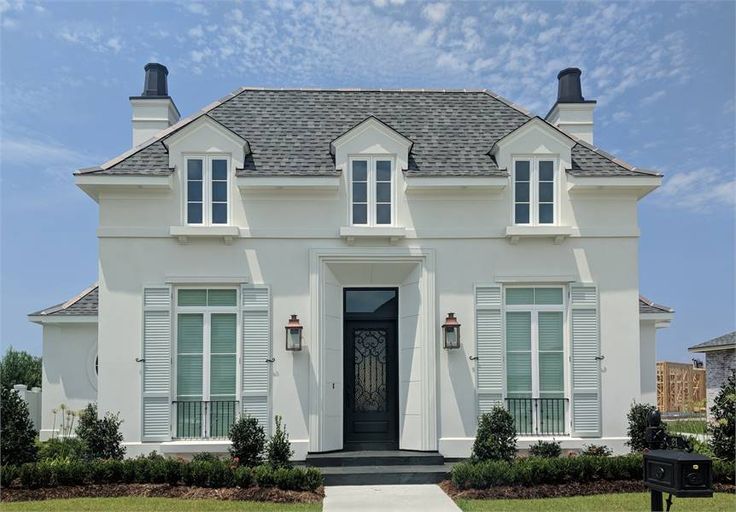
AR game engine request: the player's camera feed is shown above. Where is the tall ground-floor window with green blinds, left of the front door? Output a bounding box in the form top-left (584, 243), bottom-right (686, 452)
top-left (176, 289), bottom-right (237, 437)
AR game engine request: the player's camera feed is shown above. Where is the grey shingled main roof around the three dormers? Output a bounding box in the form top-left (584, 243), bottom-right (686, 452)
top-left (78, 88), bottom-right (658, 180)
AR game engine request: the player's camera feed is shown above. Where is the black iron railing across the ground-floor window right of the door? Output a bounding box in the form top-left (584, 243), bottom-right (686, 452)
top-left (506, 398), bottom-right (568, 436)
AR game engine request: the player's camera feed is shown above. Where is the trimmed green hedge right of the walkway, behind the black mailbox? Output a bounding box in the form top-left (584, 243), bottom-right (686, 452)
top-left (451, 454), bottom-right (734, 489)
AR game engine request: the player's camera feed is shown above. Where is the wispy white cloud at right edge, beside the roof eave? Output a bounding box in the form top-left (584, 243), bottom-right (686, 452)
top-left (655, 167), bottom-right (736, 212)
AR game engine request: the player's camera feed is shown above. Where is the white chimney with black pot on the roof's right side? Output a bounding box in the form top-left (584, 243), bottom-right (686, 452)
top-left (545, 68), bottom-right (595, 144)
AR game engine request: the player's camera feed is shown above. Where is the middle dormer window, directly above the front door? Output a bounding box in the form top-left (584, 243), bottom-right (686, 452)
top-left (350, 157), bottom-right (394, 226)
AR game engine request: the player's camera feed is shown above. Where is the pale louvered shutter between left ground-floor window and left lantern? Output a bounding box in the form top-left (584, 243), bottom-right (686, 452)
top-left (241, 285), bottom-right (271, 434)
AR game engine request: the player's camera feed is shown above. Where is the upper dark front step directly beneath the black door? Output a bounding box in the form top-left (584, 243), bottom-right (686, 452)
top-left (305, 450), bottom-right (445, 468)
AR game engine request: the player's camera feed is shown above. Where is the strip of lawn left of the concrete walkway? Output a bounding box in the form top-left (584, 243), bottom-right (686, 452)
top-left (2, 497), bottom-right (322, 512)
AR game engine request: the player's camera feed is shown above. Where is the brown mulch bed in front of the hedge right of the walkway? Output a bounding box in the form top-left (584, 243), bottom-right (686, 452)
top-left (440, 480), bottom-right (736, 500)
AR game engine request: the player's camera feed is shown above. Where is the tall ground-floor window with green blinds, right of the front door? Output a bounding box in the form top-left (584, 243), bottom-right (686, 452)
top-left (505, 287), bottom-right (565, 433)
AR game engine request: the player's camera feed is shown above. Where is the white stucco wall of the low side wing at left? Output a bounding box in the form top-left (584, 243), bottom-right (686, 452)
top-left (40, 323), bottom-right (98, 440)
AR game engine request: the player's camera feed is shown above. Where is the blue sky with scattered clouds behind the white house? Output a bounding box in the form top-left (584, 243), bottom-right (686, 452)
top-left (0, 0), bottom-right (736, 360)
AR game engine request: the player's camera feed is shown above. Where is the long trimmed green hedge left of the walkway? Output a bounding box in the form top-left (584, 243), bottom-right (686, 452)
top-left (2, 455), bottom-right (322, 491)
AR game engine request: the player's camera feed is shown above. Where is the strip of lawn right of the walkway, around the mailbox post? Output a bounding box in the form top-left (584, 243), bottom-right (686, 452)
top-left (457, 492), bottom-right (736, 512)
